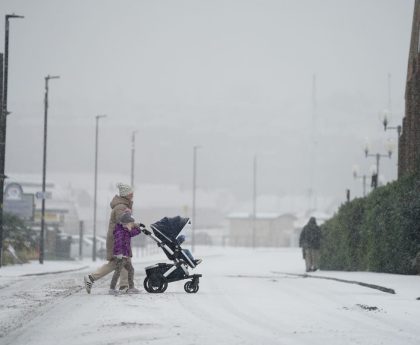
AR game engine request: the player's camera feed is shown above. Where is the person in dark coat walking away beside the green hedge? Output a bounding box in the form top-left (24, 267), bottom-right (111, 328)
top-left (299, 217), bottom-right (321, 272)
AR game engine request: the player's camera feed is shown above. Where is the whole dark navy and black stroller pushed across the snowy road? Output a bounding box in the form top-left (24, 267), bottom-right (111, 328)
top-left (143, 216), bottom-right (202, 293)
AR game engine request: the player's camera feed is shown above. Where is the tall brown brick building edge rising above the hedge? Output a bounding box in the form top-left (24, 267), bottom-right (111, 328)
top-left (398, 0), bottom-right (420, 177)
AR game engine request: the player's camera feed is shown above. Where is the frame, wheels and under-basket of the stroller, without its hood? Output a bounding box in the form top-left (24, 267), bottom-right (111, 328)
top-left (143, 225), bottom-right (202, 293)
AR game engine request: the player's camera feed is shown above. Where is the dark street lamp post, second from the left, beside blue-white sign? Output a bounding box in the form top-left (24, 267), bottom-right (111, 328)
top-left (39, 75), bottom-right (60, 264)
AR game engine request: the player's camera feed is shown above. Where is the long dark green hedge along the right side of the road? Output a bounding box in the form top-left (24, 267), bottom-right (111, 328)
top-left (321, 176), bottom-right (420, 274)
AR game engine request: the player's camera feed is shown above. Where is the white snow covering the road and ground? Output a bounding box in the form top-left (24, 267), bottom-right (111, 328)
top-left (0, 247), bottom-right (420, 345)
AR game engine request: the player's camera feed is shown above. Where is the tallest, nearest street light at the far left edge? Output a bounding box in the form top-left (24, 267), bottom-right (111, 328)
top-left (0, 14), bottom-right (24, 267)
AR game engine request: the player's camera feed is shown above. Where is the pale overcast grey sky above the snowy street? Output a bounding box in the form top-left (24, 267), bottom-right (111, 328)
top-left (0, 0), bottom-right (414, 198)
